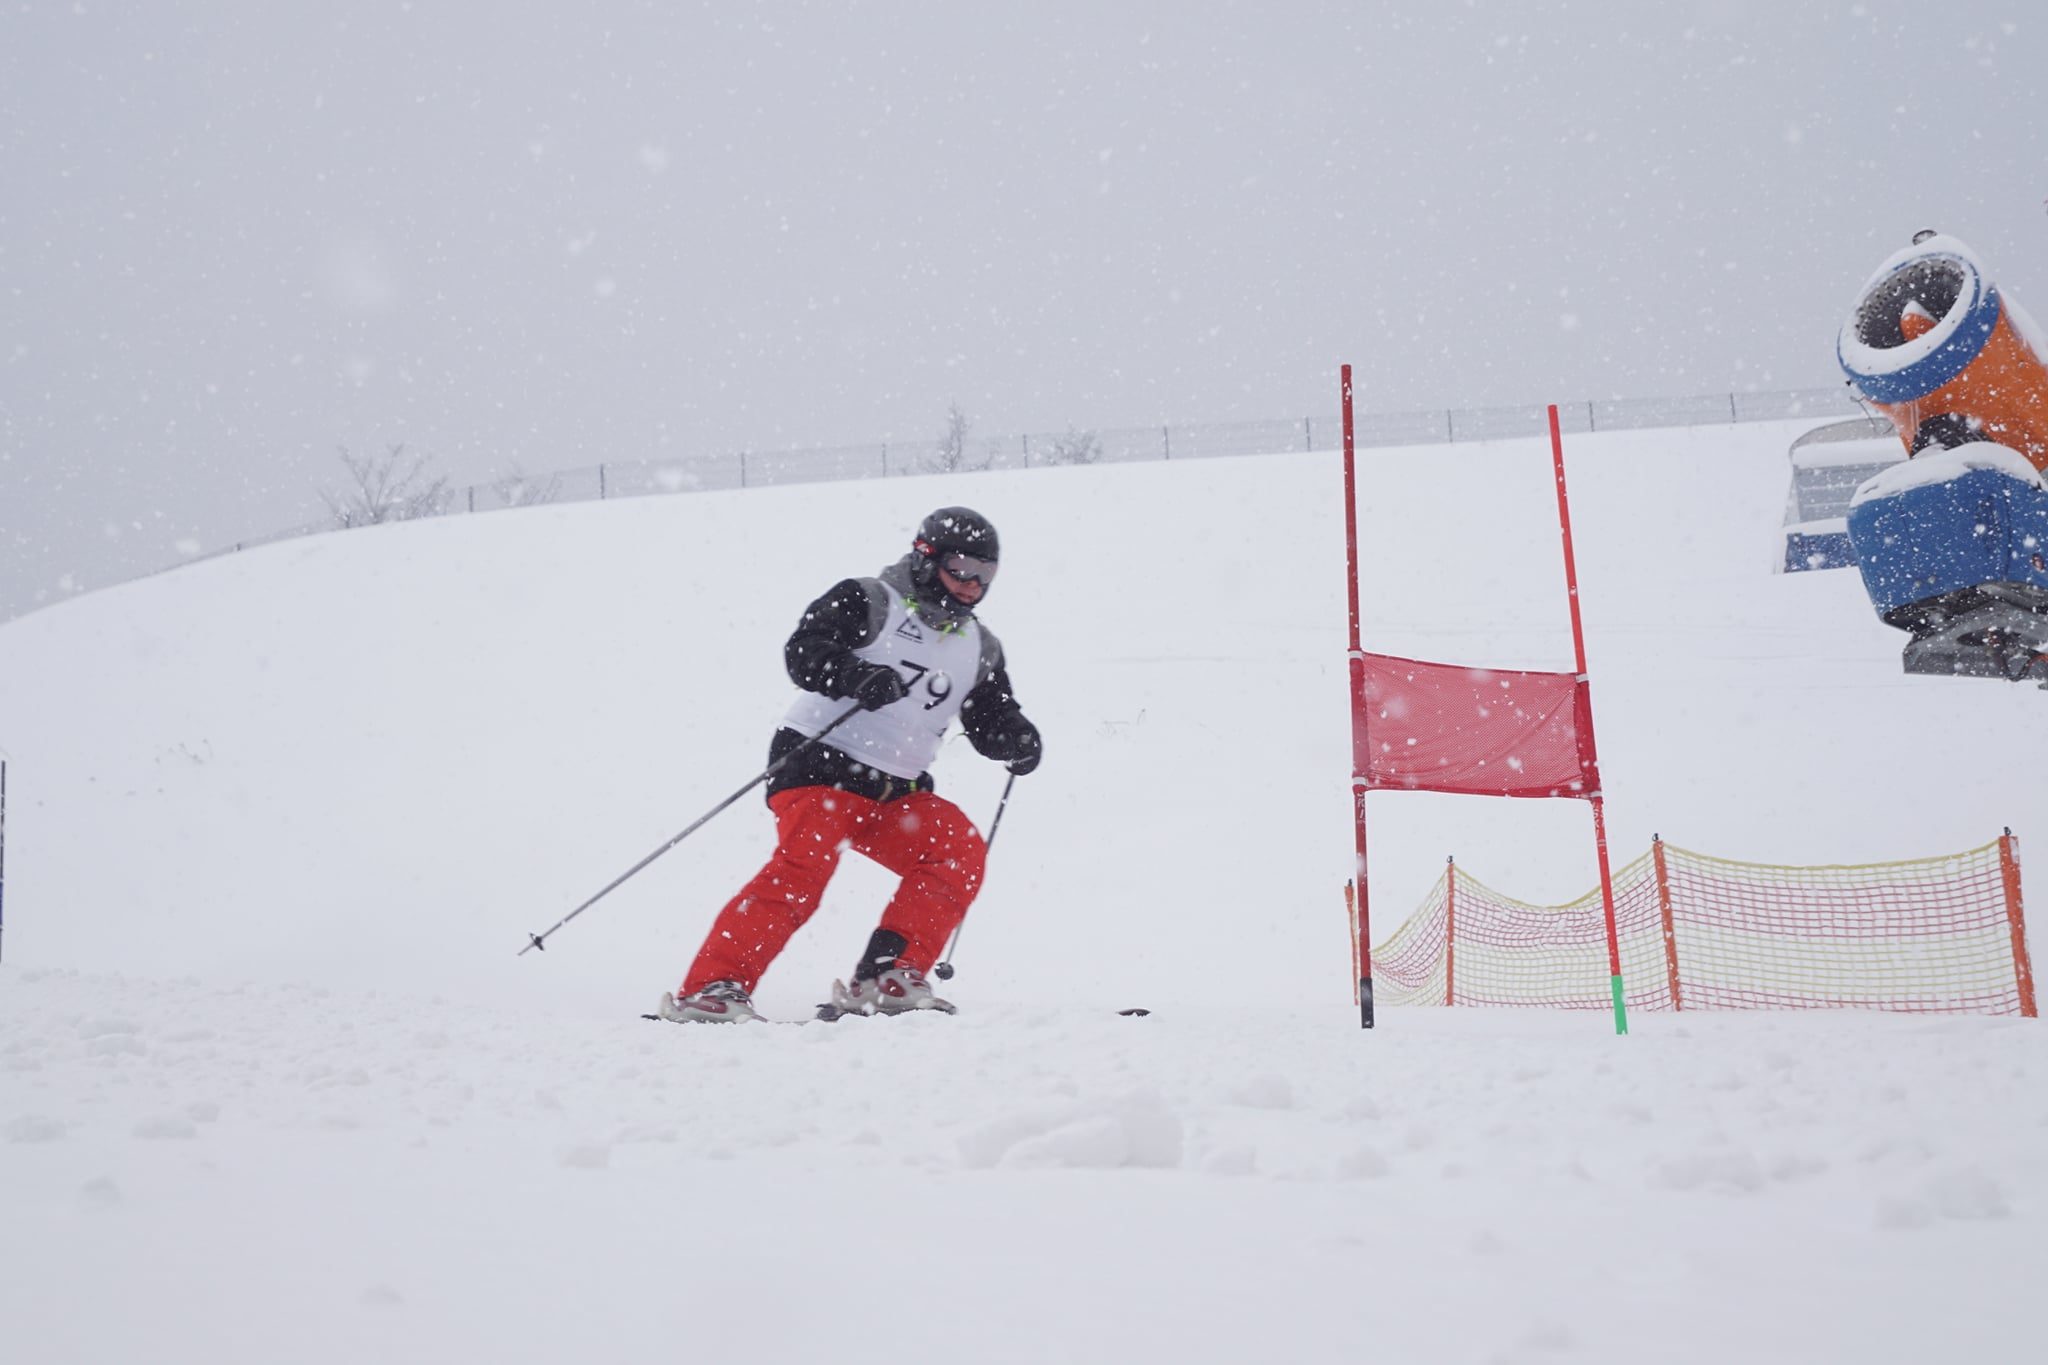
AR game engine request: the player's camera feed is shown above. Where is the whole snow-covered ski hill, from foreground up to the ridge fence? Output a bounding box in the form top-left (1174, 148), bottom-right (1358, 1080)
top-left (0, 426), bottom-right (2048, 1361)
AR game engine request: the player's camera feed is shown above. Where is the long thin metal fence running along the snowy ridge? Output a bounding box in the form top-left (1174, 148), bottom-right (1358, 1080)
top-left (184, 387), bottom-right (1864, 563)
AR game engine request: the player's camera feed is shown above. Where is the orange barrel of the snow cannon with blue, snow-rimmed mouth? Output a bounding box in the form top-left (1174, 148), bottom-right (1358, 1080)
top-left (1835, 233), bottom-right (2048, 471)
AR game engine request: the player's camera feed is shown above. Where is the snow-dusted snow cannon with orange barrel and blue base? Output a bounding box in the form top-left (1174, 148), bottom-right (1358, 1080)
top-left (1835, 233), bottom-right (2048, 688)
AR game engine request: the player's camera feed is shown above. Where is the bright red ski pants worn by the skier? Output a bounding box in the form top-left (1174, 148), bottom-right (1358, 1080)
top-left (682, 786), bottom-right (989, 995)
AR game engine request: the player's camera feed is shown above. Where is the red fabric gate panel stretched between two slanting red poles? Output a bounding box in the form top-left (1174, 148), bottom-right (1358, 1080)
top-left (1352, 655), bottom-right (1599, 796)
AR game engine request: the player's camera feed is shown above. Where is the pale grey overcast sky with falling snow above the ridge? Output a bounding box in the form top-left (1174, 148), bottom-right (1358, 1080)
top-left (0, 0), bottom-right (2048, 616)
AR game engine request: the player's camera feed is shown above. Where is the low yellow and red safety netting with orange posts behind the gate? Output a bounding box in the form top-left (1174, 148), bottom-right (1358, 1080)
top-left (1372, 839), bottom-right (2034, 1015)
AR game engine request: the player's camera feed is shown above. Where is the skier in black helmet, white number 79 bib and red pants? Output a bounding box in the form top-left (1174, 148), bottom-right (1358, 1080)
top-left (659, 508), bottom-right (1042, 1023)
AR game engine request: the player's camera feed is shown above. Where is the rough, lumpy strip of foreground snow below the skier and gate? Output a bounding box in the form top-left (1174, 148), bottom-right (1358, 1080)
top-left (0, 968), bottom-right (2048, 1365)
